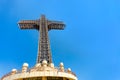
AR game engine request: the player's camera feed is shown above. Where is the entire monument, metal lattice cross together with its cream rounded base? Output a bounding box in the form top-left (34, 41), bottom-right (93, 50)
top-left (2, 15), bottom-right (77, 80)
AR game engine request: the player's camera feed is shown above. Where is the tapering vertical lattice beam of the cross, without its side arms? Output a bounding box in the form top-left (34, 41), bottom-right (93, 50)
top-left (37, 15), bottom-right (52, 63)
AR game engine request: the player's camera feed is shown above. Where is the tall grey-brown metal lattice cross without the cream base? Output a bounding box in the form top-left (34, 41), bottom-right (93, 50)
top-left (18, 15), bottom-right (65, 63)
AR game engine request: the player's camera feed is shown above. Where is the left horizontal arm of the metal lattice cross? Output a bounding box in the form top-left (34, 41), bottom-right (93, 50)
top-left (18, 20), bottom-right (39, 30)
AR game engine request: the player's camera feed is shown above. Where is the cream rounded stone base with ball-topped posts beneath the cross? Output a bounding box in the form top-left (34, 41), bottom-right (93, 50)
top-left (2, 60), bottom-right (78, 80)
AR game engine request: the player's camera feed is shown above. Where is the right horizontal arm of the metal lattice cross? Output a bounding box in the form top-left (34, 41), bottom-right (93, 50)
top-left (48, 21), bottom-right (65, 30)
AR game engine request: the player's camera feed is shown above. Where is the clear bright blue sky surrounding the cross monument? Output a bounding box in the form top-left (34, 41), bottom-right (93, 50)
top-left (0, 0), bottom-right (120, 80)
